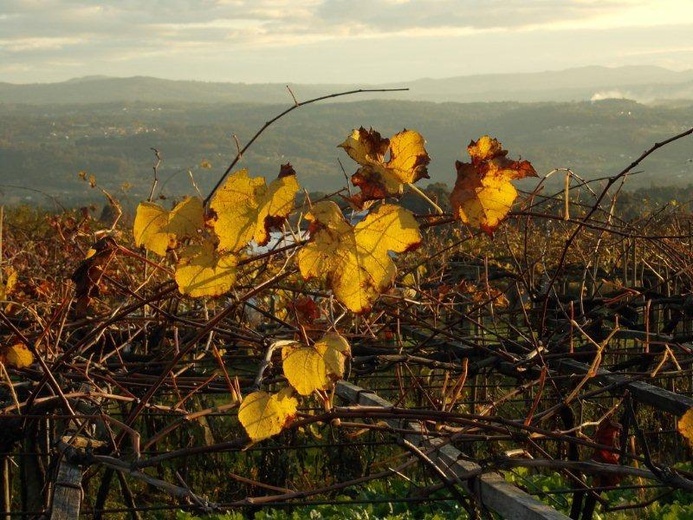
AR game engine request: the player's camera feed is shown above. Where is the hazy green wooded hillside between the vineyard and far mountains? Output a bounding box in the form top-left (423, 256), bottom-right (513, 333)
top-left (0, 97), bottom-right (693, 204)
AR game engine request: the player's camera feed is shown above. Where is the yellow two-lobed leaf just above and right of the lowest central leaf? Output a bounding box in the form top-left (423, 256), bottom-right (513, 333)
top-left (282, 332), bottom-right (351, 395)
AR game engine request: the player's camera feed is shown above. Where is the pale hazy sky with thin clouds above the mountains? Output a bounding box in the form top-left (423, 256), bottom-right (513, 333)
top-left (0, 0), bottom-right (693, 84)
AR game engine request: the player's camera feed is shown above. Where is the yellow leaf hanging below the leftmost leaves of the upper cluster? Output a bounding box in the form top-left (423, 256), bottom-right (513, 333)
top-left (175, 241), bottom-right (238, 297)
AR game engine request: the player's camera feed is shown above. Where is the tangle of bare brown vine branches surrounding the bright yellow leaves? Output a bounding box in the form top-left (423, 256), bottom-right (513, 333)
top-left (0, 91), bottom-right (693, 519)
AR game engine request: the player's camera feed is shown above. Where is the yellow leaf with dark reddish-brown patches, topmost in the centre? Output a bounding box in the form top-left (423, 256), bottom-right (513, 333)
top-left (339, 127), bottom-right (431, 207)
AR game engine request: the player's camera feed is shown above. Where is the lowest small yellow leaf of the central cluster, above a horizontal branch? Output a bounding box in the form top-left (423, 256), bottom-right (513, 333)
top-left (238, 388), bottom-right (298, 442)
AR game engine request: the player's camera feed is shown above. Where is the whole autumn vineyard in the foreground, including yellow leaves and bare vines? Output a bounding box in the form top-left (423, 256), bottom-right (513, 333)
top-left (0, 96), bottom-right (693, 520)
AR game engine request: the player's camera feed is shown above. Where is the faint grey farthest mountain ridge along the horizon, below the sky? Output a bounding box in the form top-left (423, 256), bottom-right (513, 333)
top-left (0, 66), bottom-right (693, 105)
